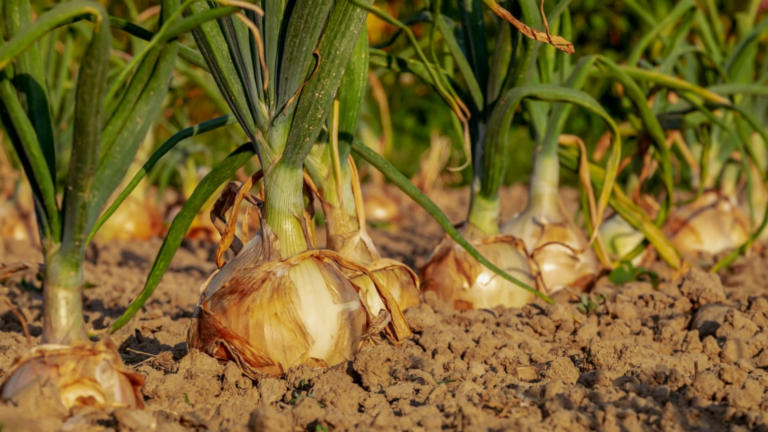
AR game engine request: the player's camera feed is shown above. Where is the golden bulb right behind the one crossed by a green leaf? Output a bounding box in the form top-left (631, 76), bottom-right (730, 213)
top-left (501, 213), bottom-right (600, 294)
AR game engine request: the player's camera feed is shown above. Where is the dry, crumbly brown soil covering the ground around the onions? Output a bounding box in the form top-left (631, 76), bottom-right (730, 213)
top-left (0, 187), bottom-right (768, 432)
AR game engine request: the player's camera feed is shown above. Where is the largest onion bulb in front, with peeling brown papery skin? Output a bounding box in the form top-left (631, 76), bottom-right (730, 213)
top-left (187, 221), bottom-right (410, 378)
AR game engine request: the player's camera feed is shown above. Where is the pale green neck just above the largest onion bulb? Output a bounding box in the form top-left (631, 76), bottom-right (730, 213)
top-left (264, 163), bottom-right (309, 260)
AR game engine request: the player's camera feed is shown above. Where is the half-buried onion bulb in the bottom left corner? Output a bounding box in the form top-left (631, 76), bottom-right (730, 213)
top-left (0, 339), bottom-right (144, 411)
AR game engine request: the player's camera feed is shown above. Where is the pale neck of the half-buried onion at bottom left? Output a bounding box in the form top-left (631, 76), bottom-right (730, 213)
top-left (42, 246), bottom-right (88, 345)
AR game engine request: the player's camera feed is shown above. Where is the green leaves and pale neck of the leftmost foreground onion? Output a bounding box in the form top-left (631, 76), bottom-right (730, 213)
top-left (0, 0), bottom-right (187, 344)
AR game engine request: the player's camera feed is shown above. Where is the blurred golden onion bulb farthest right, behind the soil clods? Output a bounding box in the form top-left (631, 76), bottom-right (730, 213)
top-left (666, 191), bottom-right (750, 257)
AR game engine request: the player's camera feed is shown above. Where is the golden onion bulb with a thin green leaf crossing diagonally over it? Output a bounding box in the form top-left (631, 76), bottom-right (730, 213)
top-left (421, 236), bottom-right (534, 310)
